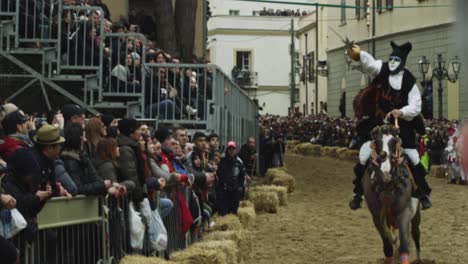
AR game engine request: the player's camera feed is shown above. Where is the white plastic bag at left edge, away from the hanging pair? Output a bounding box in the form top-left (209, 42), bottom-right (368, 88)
top-left (0, 209), bottom-right (28, 239)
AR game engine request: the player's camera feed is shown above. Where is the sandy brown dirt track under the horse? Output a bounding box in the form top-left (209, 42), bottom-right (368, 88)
top-left (248, 156), bottom-right (468, 264)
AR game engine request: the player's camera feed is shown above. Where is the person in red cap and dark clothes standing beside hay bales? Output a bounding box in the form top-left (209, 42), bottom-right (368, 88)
top-left (216, 141), bottom-right (247, 216)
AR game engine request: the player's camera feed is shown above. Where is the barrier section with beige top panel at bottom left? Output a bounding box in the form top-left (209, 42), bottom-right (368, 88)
top-left (13, 196), bottom-right (109, 264)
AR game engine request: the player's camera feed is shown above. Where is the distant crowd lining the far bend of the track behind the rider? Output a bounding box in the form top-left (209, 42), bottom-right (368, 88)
top-left (260, 113), bottom-right (467, 183)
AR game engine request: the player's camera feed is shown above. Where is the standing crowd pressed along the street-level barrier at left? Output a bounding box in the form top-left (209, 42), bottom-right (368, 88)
top-left (0, 100), bottom-right (256, 263)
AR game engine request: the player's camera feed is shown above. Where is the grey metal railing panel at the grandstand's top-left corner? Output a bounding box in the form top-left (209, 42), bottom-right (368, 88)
top-left (16, 0), bottom-right (62, 47)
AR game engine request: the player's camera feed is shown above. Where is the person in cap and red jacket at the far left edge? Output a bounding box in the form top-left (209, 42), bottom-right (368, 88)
top-left (0, 110), bottom-right (34, 159)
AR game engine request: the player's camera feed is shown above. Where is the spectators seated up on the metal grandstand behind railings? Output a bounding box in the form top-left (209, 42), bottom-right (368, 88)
top-left (13, 0), bottom-right (213, 120)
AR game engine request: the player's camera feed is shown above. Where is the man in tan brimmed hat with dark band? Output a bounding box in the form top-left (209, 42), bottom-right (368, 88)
top-left (33, 125), bottom-right (72, 199)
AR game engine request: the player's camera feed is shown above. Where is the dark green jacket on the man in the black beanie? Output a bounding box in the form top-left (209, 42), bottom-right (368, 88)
top-left (117, 134), bottom-right (145, 202)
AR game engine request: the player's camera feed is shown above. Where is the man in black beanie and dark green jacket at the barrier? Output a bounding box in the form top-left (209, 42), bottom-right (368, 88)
top-left (117, 119), bottom-right (146, 203)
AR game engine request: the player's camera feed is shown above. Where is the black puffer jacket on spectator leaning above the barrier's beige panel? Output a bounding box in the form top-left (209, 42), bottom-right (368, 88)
top-left (60, 150), bottom-right (107, 195)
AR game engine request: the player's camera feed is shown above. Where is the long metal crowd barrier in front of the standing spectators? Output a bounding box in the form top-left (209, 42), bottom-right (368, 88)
top-left (8, 186), bottom-right (197, 264)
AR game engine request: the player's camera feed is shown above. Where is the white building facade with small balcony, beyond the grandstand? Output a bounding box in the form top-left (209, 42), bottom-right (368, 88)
top-left (207, 0), bottom-right (313, 115)
